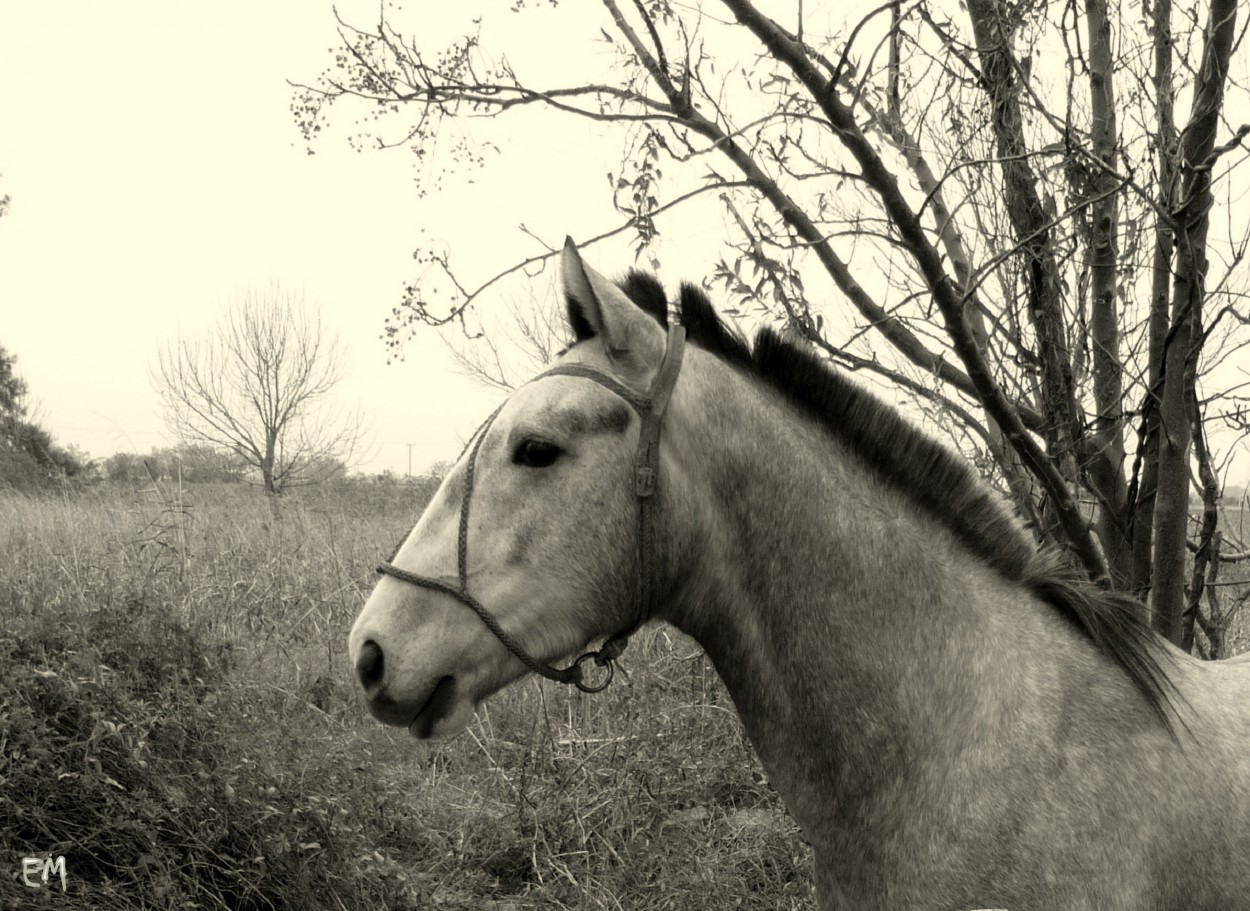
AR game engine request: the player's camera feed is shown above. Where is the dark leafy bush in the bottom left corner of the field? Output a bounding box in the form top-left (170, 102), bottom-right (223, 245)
top-left (0, 589), bottom-right (425, 911)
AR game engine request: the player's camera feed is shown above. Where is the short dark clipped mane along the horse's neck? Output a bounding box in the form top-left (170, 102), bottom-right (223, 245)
top-left (619, 271), bottom-right (1173, 729)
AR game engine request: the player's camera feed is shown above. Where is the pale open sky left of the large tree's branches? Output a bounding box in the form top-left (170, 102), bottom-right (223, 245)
top-left (0, 0), bottom-right (655, 472)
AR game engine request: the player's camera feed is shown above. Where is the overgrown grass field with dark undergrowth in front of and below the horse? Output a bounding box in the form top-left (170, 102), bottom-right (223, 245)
top-left (0, 484), bottom-right (814, 911)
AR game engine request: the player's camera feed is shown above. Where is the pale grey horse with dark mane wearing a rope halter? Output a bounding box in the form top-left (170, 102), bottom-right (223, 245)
top-left (349, 241), bottom-right (1250, 911)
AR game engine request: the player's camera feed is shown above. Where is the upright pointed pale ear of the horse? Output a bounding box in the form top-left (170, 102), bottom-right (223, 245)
top-left (560, 237), bottom-right (664, 369)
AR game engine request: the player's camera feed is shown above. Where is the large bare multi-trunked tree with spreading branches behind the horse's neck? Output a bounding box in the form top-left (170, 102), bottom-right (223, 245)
top-left (294, 0), bottom-right (1250, 654)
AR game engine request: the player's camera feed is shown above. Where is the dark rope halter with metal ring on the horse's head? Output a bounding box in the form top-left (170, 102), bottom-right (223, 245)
top-left (378, 319), bottom-right (686, 692)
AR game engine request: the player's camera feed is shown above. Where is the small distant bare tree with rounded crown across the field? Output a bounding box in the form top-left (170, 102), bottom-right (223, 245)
top-left (153, 286), bottom-right (361, 495)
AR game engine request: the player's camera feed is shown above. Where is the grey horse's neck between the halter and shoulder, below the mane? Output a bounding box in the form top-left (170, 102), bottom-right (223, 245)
top-left (665, 367), bottom-right (1053, 836)
